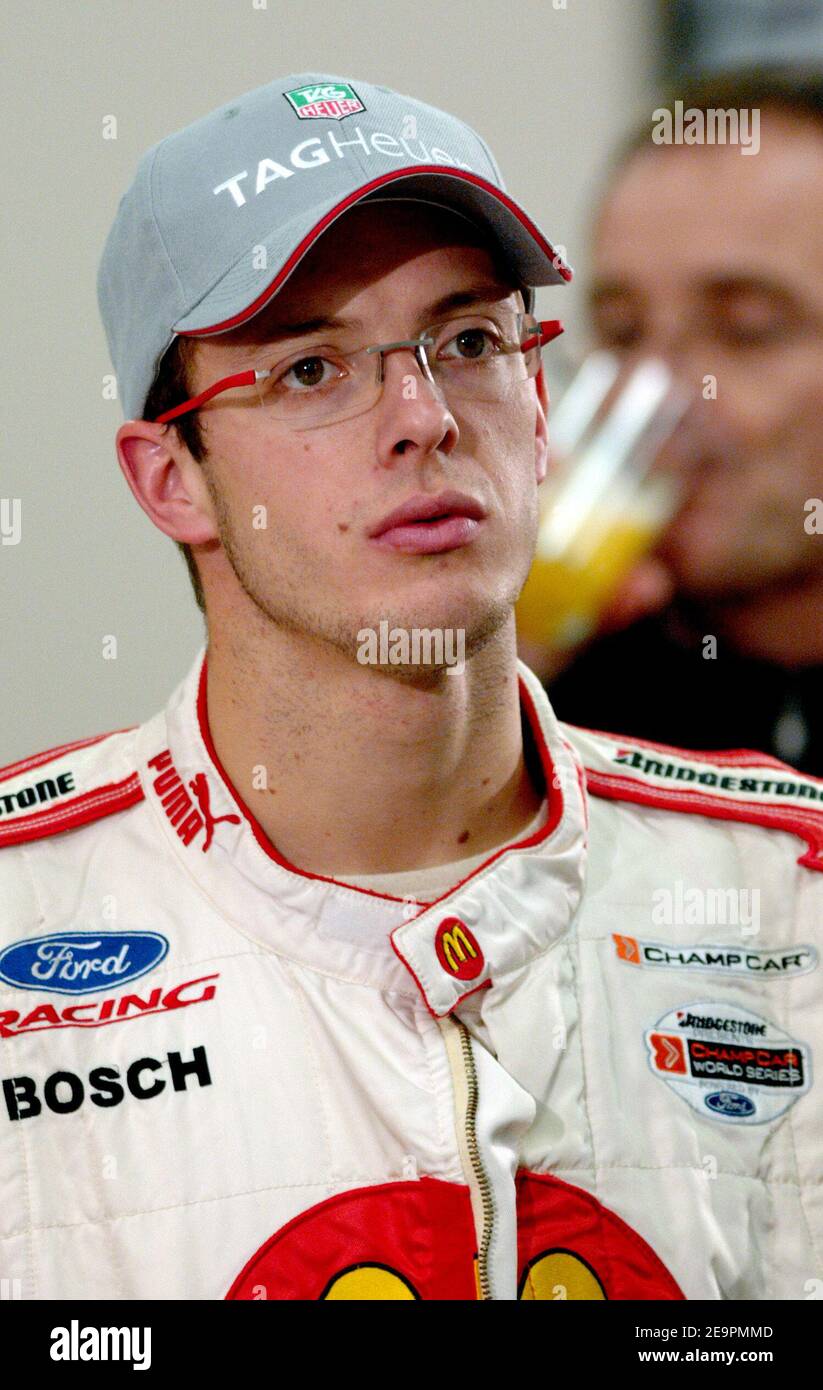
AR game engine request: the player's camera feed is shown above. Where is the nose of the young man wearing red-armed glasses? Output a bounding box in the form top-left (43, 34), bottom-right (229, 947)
top-left (378, 348), bottom-right (460, 467)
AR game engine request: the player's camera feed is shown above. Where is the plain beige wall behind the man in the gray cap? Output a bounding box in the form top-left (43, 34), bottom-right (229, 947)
top-left (0, 0), bottom-right (652, 763)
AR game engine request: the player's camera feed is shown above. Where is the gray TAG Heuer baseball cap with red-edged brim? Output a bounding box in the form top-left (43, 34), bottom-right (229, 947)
top-left (97, 72), bottom-right (571, 420)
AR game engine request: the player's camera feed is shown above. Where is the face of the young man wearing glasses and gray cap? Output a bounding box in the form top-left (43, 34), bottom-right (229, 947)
top-left (183, 203), bottom-right (546, 667)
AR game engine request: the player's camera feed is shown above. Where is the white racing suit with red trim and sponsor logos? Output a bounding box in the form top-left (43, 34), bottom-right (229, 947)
top-left (0, 657), bottom-right (823, 1300)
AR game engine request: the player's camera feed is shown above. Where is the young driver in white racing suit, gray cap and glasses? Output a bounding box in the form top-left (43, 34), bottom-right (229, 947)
top-left (0, 75), bottom-right (823, 1300)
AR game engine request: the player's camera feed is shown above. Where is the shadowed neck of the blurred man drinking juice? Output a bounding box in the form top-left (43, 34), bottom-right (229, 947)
top-left (692, 573), bottom-right (823, 669)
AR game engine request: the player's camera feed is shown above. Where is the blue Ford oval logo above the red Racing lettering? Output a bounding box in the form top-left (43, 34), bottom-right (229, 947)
top-left (0, 931), bottom-right (168, 994)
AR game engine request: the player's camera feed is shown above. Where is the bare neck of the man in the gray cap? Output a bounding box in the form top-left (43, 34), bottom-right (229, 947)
top-left (207, 621), bottom-right (545, 877)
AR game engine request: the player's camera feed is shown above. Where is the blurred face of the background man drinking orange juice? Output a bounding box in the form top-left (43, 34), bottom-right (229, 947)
top-left (592, 111), bottom-right (823, 596)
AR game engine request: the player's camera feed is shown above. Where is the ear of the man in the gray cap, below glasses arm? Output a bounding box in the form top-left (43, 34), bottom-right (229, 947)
top-left (115, 420), bottom-right (218, 545)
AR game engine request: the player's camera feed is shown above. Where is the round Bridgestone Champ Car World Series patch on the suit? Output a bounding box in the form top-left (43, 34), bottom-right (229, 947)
top-left (645, 1002), bottom-right (812, 1125)
